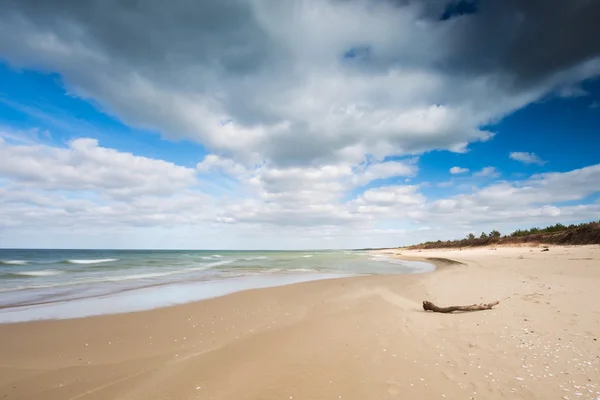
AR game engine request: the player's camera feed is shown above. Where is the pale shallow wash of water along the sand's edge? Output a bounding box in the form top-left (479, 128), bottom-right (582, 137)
top-left (0, 253), bottom-right (435, 324)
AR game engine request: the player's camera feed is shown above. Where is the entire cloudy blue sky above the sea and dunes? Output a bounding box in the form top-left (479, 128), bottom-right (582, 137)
top-left (0, 0), bottom-right (600, 249)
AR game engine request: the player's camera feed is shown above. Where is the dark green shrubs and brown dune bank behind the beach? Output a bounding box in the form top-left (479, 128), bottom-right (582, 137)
top-left (408, 220), bottom-right (600, 249)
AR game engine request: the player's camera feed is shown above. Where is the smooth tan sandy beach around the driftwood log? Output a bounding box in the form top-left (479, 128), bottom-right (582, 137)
top-left (0, 246), bottom-right (600, 400)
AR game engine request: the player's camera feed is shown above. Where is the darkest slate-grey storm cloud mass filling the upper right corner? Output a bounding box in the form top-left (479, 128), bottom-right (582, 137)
top-left (430, 0), bottom-right (600, 87)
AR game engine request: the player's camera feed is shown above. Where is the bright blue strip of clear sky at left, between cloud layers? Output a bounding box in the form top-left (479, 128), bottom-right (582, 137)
top-left (0, 62), bottom-right (206, 166)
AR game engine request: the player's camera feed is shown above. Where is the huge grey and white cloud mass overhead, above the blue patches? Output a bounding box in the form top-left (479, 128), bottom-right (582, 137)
top-left (0, 0), bottom-right (600, 167)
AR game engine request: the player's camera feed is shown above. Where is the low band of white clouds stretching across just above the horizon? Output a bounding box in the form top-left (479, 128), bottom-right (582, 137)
top-left (0, 136), bottom-right (600, 248)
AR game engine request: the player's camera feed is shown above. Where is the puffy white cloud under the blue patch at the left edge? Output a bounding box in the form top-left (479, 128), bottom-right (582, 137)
top-left (0, 138), bottom-right (195, 197)
